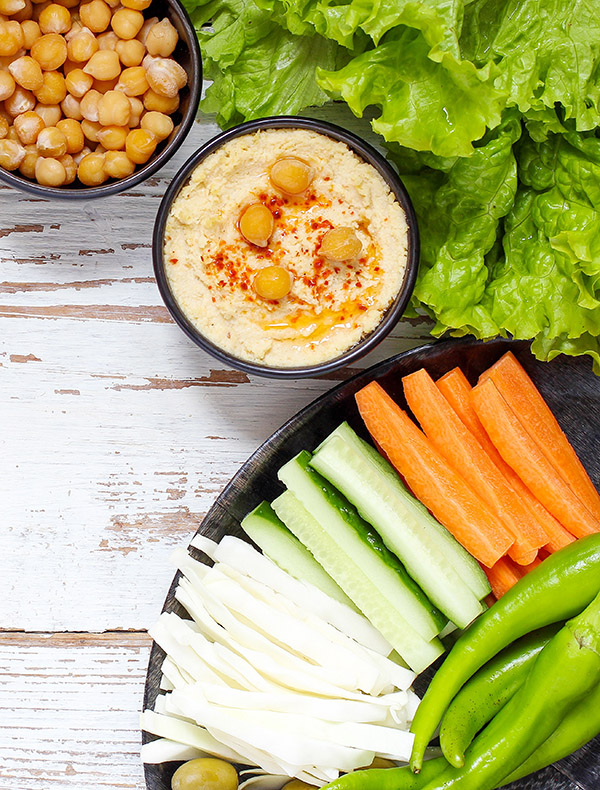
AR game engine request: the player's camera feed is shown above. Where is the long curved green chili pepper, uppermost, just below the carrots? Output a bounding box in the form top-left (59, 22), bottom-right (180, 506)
top-left (410, 534), bottom-right (600, 772)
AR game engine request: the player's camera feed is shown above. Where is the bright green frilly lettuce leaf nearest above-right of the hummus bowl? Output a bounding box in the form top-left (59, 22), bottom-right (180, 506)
top-left (317, 27), bottom-right (505, 157)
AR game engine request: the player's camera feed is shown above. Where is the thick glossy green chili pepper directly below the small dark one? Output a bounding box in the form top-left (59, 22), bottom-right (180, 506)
top-left (421, 594), bottom-right (600, 790)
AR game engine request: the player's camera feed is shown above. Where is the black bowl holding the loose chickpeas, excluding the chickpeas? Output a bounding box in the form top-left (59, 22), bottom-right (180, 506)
top-left (0, 0), bottom-right (202, 200)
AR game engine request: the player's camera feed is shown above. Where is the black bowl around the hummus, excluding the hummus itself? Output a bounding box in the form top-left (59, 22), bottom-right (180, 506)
top-left (152, 116), bottom-right (419, 379)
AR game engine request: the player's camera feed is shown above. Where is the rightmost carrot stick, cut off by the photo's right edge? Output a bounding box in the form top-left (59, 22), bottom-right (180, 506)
top-left (483, 351), bottom-right (600, 520)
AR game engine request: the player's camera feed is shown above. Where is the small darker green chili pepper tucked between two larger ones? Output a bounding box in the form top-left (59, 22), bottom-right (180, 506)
top-left (440, 625), bottom-right (559, 768)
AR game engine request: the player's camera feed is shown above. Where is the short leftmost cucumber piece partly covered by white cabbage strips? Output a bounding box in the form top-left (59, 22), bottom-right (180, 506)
top-left (242, 502), bottom-right (356, 609)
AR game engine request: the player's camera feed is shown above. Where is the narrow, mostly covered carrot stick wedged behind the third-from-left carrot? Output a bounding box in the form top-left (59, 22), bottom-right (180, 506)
top-left (436, 368), bottom-right (575, 552)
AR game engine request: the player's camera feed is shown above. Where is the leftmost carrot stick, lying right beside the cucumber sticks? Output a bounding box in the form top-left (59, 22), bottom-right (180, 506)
top-left (356, 382), bottom-right (513, 567)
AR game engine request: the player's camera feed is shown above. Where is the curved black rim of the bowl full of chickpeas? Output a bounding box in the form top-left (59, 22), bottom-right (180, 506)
top-left (0, 0), bottom-right (202, 200)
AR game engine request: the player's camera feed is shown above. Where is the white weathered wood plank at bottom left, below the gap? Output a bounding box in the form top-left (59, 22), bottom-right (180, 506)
top-left (0, 633), bottom-right (150, 790)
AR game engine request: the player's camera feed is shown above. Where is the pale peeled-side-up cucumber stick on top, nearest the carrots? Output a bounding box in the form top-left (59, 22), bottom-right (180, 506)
top-left (311, 436), bottom-right (481, 628)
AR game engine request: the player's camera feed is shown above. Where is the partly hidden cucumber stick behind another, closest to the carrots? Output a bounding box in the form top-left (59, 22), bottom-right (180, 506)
top-left (314, 422), bottom-right (491, 600)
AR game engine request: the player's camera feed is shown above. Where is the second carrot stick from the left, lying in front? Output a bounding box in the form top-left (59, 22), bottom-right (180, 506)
top-left (402, 368), bottom-right (548, 565)
